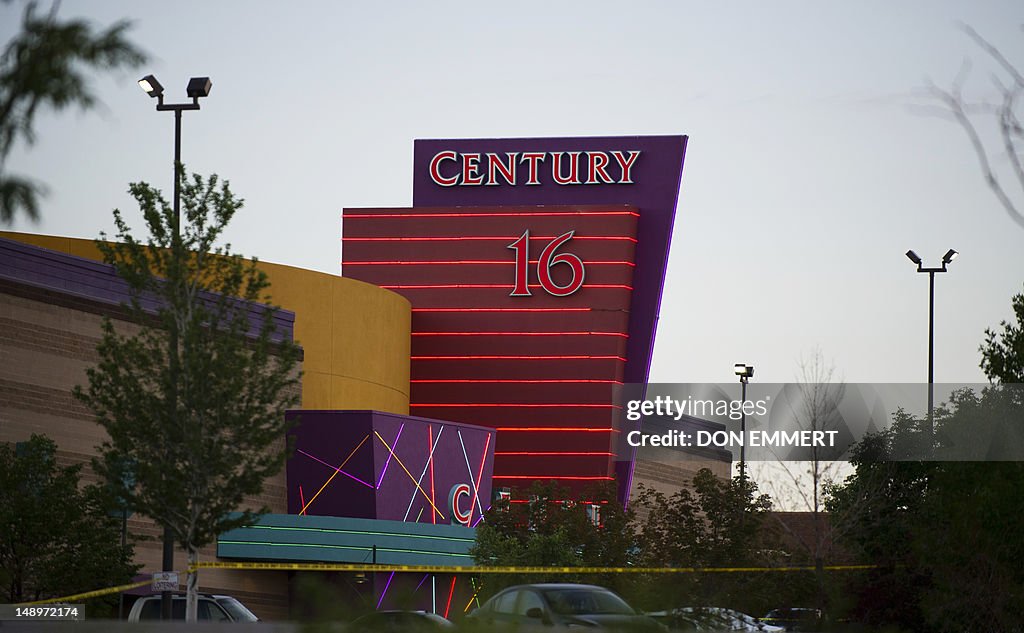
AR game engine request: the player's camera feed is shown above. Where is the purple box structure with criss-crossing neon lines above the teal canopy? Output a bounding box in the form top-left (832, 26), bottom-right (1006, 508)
top-left (288, 411), bottom-right (496, 526)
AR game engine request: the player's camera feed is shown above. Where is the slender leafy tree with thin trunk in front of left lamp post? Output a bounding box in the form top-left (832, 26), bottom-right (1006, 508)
top-left (76, 168), bottom-right (301, 619)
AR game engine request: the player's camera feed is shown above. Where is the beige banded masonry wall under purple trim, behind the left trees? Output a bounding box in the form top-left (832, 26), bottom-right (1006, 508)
top-left (0, 292), bottom-right (296, 620)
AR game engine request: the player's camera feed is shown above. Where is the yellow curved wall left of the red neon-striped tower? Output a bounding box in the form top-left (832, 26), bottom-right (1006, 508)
top-left (0, 231), bottom-right (412, 415)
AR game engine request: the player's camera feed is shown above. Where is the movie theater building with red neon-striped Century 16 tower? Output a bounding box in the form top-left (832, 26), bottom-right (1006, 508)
top-left (0, 136), bottom-right (730, 619)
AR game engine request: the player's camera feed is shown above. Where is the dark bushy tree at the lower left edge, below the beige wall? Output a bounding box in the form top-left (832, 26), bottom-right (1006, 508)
top-left (0, 435), bottom-right (138, 603)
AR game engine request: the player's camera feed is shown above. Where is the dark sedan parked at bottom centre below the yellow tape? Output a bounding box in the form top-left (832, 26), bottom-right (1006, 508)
top-left (469, 583), bottom-right (666, 631)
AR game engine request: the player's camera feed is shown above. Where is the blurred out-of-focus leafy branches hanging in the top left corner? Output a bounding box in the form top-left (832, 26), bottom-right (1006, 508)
top-left (0, 2), bottom-right (145, 222)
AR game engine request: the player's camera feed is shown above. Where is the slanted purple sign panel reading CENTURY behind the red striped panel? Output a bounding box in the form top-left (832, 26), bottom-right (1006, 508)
top-left (413, 136), bottom-right (687, 383)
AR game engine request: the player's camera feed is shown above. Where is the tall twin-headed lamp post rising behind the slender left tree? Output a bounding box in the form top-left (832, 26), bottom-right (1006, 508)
top-left (138, 75), bottom-right (213, 620)
